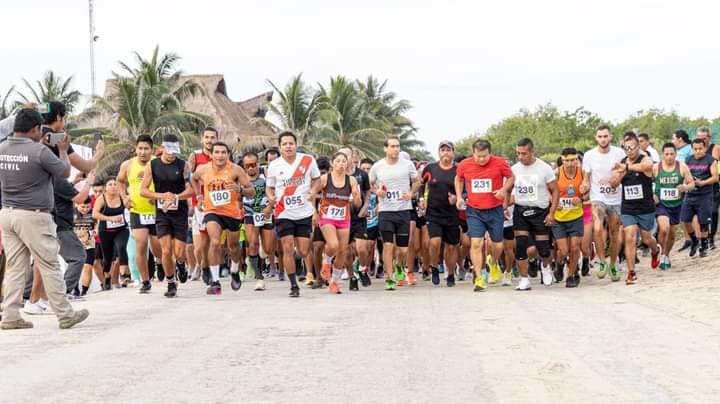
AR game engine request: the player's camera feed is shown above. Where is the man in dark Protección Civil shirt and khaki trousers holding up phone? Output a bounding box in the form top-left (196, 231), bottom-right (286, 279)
top-left (0, 109), bottom-right (89, 330)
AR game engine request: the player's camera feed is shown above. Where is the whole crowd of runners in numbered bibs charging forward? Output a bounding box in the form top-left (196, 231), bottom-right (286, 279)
top-left (3, 100), bottom-right (720, 328)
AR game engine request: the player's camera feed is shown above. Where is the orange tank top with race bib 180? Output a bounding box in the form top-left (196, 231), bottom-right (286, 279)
top-left (203, 164), bottom-right (243, 219)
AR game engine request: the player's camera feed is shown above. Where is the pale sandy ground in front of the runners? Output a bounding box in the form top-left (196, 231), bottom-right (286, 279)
top-left (0, 252), bottom-right (720, 403)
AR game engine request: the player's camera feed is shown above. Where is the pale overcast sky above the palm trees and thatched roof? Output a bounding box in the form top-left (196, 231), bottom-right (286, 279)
top-left (0, 0), bottom-right (720, 151)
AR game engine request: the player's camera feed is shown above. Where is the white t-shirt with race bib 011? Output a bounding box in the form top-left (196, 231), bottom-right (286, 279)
top-left (370, 158), bottom-right (418, 212)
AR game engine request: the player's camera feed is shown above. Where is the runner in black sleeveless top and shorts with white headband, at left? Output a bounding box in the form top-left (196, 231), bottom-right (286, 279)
top-left (140, 134), bottom-right (195, 297)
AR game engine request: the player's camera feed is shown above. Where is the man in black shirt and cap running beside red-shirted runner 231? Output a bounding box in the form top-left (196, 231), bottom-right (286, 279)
top-left (421, 140), bottom-right (460, 287)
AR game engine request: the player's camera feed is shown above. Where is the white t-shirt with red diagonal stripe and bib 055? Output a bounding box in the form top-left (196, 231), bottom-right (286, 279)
top-left (266, 153), bottom-right (320, 220)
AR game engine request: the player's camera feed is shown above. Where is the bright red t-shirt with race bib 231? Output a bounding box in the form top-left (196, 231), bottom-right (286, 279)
top-left (457, 156), bottom-right (512, 209)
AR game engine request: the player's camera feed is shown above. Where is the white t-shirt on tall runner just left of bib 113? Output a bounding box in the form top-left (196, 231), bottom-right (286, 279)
top-left (583, 146), bottom-right (625, 205)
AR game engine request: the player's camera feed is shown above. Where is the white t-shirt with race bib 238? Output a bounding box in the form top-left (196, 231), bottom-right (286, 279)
top-left (512, 159), bottom-right (555, 209)
